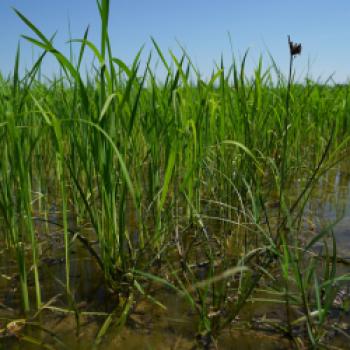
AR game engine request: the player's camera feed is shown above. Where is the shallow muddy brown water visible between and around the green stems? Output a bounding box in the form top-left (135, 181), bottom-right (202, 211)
top-left (0, 161), bottom-right (350, 349)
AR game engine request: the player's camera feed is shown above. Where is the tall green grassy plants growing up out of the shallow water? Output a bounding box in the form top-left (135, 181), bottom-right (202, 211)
top-left (0, 0), bottom-right (350, 348)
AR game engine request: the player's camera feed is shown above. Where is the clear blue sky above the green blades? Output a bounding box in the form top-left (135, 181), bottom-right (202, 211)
top-left (0, 0), bottom-right (350, 82)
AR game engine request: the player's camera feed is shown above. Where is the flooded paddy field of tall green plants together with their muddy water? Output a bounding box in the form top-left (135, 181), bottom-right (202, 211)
top-left (0, 0), bottom-right (350, 350)
